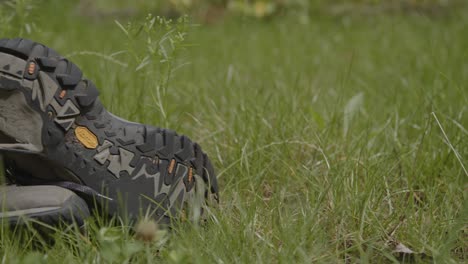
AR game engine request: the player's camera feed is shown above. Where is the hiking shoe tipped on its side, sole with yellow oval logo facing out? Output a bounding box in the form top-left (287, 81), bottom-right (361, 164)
top-left (0, 39), bottom-right (218, 223)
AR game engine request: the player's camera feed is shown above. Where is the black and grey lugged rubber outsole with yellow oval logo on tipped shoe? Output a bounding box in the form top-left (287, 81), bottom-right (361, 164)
top-left (0, 39), bottom-right (218, 221)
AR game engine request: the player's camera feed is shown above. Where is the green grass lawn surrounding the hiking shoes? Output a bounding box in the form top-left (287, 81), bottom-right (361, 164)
top-left (0, 1), bottom-right (468, 263)
